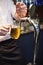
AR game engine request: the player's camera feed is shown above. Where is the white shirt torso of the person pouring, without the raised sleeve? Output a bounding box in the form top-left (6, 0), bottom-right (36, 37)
top-left (0, 0), bottom-right (13, 41)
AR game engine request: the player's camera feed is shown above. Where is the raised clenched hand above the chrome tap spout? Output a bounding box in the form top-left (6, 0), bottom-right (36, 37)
top-left (16, 2), bottom-right (27, 17)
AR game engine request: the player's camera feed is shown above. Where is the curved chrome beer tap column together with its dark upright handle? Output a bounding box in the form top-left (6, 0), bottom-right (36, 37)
top-left (21, 4), bottom-right (40, 65)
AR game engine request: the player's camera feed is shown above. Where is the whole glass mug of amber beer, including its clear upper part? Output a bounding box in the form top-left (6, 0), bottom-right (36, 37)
top-left (10, 21), bottom-right (20, 39)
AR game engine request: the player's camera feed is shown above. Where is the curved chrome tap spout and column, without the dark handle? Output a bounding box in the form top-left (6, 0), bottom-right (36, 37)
top-left (21, 14), bottom-right (40, 65)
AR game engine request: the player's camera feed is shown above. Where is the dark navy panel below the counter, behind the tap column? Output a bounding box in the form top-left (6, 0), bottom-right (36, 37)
top-left (17, 30), bottom-right (43, 65)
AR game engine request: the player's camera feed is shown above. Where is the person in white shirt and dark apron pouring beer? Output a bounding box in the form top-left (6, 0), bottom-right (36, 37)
top-left (0, 0), bottom-right (27, 65)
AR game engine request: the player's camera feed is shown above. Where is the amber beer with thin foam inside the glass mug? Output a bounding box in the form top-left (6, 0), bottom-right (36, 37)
top-left (11, 26), bottom-right (20, 39)
